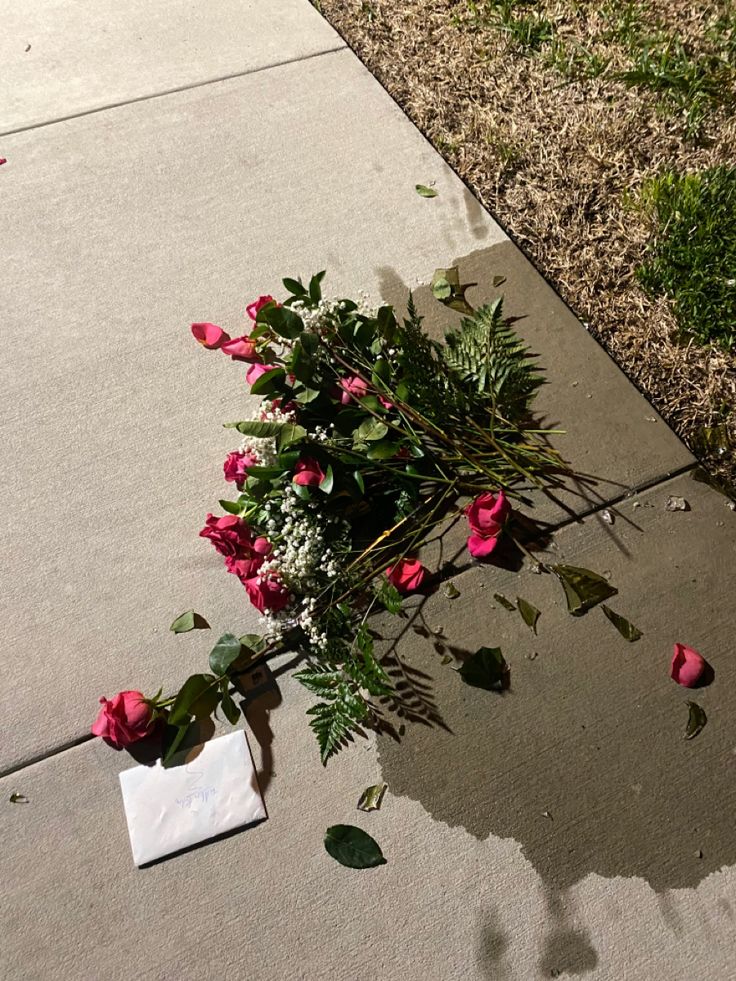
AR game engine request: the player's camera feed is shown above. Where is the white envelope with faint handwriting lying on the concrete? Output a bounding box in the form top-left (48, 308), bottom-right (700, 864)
top-left (115, 730), bottom-right (267, 865)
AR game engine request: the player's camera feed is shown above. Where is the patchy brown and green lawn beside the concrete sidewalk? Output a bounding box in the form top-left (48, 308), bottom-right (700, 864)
top-left (313, 0), bottom-right (736, 486)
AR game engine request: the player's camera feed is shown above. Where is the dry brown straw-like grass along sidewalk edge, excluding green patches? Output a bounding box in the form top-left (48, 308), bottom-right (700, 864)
top-left (318, 0), bottom-right (736, 490)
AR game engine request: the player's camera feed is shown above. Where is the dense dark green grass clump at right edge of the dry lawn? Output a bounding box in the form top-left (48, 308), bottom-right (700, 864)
top-left (637, 166), bottom-right (736, 350)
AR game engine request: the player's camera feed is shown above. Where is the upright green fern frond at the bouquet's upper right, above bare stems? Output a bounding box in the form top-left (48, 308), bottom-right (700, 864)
top-left (442, 297), bottom-right (544, 419)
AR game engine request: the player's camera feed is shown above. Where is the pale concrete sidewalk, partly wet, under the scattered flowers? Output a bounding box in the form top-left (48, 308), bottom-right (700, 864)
top-left (0, 0), bottom-right (736, 981)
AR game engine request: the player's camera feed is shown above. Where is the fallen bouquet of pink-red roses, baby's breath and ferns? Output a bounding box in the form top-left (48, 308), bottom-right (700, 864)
top-left (96, 270), bottom-right (564, 762)
